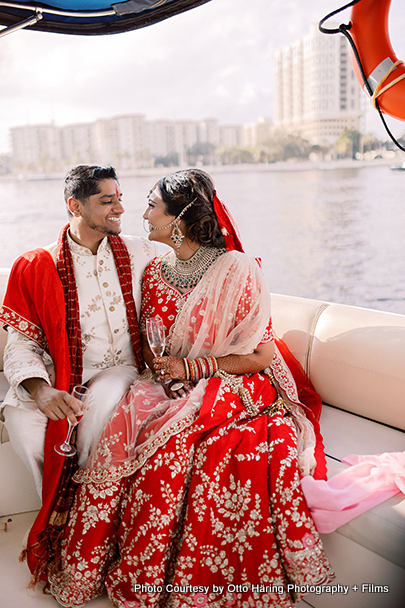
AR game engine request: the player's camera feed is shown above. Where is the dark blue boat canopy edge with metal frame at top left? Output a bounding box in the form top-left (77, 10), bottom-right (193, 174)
top-left (0, 0), bottom-right (211, 37)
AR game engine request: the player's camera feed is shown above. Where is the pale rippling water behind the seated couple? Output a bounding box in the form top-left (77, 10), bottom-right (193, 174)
top-left (0, 165), bottom-right (405, 314)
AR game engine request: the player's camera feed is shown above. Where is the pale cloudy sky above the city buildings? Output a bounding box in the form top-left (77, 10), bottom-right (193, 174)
top-left (0, 0), bottom-right (405, 153)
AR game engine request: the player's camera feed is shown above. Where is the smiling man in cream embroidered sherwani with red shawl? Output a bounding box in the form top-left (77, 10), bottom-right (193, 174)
top-left (0, 165), bottom-right (156, 500)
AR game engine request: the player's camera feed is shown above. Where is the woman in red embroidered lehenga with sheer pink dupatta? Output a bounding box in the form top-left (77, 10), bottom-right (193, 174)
top-left (41, 169), bottom-right (333, 608)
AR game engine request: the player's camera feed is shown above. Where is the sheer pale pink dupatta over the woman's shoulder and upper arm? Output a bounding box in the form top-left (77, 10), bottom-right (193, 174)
top-left (169, 251), bottom-right (270, 359)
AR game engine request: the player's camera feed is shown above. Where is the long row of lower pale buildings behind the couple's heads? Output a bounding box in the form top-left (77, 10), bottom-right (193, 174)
top-left (11, 114), bottom-right (273, 171)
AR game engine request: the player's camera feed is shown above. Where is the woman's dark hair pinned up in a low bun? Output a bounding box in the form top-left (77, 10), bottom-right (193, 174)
top-left (157, 169), bottom-right (225, 248)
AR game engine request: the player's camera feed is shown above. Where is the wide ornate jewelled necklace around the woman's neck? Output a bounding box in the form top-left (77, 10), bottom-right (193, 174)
top-left (162, 246), bottom-right (227, 289)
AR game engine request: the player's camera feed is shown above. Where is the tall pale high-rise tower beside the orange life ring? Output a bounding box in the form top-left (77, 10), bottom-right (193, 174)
top-left (274, 25), bottom-right (362, 143)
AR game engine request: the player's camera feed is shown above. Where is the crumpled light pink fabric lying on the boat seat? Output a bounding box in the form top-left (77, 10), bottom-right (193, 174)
top-left (301, 452), bottom-right (405, 533)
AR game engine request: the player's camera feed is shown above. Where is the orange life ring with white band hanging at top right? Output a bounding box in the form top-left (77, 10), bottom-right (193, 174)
top-left (350, 0), bottom-right (405, 120)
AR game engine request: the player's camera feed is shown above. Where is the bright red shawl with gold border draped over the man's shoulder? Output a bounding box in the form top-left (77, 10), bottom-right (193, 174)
top-left (0, 249), bottom-right (74, 577)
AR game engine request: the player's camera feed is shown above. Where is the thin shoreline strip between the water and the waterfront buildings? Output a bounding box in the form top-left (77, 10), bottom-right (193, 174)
top-left (0, 155), bottom-right (404, 182)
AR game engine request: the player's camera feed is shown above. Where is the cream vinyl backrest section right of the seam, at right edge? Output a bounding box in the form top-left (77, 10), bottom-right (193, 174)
top-left (309, 304), bottom-right (405, 430)
